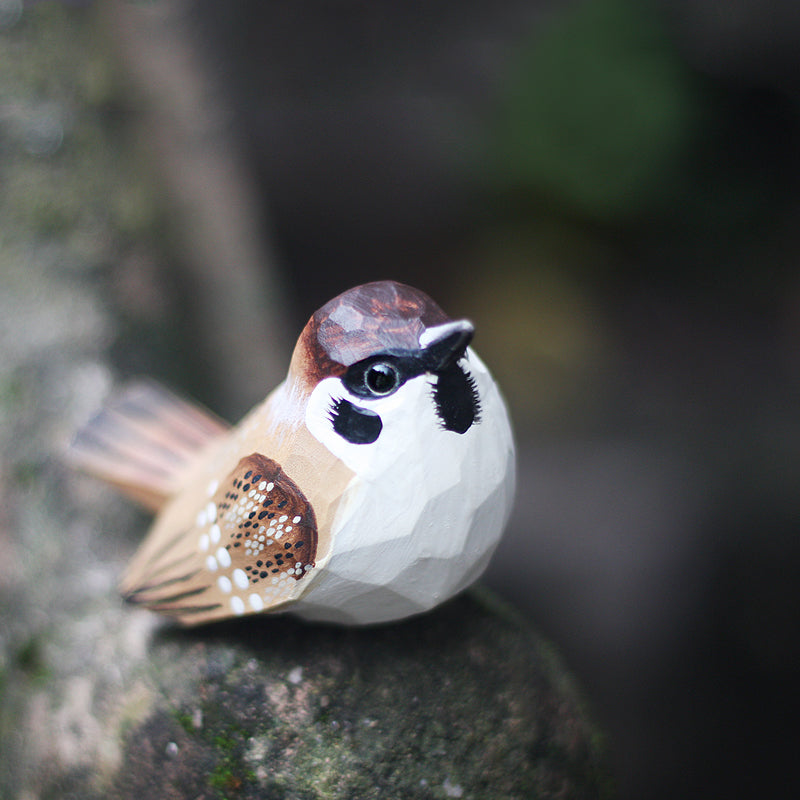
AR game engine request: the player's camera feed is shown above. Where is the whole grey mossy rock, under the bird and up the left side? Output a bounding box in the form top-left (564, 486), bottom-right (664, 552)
top-left (0, 4), bottom-right (608, 800)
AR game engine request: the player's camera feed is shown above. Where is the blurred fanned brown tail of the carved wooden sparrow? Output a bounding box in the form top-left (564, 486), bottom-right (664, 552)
top-left (67, 381), bottom-right (228, 511)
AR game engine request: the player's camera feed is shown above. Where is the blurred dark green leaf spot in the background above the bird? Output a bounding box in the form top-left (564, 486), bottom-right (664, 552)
top-left (492, 0), bottom-right (703, 222)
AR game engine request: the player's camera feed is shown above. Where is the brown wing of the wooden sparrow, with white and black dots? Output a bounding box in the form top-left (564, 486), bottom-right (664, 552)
top-left (123, 453), bottom-right (317, 625)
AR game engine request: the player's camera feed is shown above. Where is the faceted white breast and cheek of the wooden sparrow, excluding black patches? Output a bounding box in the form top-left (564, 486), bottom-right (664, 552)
top-left (292, 350), bottom-right (515, 624)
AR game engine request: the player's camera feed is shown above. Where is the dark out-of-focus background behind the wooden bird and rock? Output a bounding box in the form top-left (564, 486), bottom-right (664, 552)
top-left (0, 0), bottom-right (800, 798)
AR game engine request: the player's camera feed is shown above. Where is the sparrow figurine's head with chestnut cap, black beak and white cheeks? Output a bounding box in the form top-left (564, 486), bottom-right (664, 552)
top-left (290, 281), bottom-right (488, 470)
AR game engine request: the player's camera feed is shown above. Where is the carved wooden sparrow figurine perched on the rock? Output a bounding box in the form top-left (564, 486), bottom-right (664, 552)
top-left (71, 281), bottom-right (515, 625)
